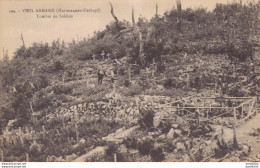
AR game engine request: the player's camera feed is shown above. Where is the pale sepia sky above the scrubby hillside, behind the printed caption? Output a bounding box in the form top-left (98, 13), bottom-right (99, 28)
top-left (0, 0), bottom-right (245, 60)
